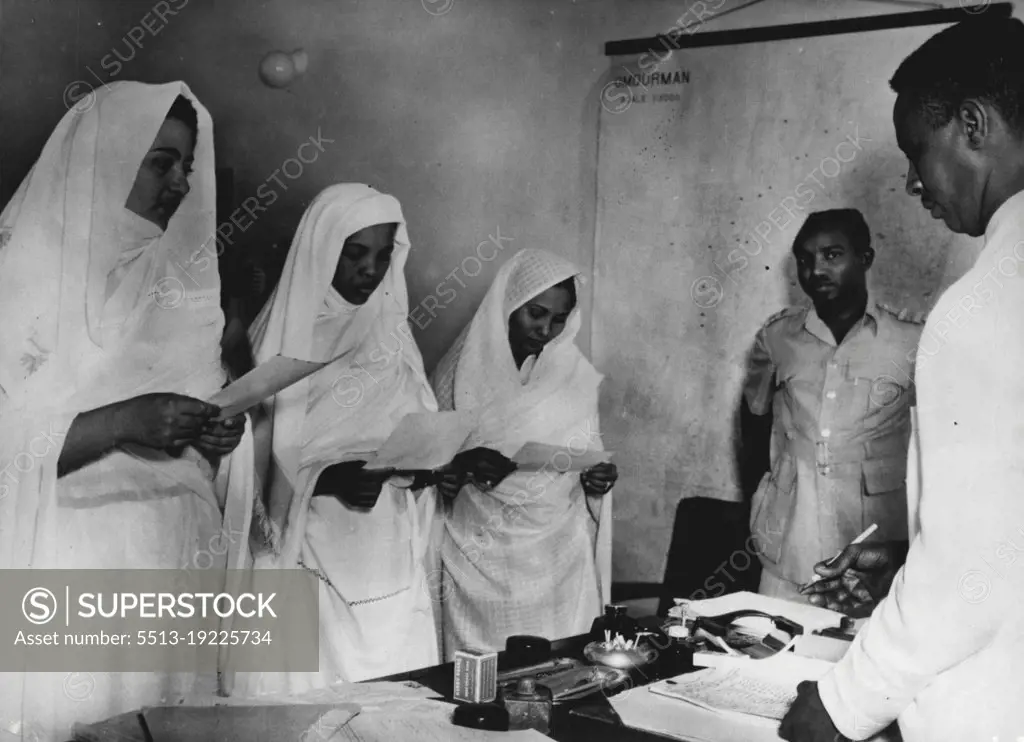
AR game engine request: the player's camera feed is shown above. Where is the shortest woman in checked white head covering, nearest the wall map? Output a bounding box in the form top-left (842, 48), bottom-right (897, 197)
top-left (433, 250), bottom-right (617, 658)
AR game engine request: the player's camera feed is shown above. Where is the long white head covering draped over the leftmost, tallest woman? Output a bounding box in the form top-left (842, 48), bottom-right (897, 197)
top-left (0, 82), bottom-right (223, 567)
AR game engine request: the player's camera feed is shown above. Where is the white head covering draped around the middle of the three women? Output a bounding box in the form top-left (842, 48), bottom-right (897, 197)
top-left (249, 183), bottom-right (436, 561)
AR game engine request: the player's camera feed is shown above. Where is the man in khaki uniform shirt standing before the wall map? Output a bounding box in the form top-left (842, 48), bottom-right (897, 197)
top-left (743, 209), bottom-right (923, 600)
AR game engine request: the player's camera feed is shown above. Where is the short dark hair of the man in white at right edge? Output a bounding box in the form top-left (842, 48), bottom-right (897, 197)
top-left (889, 17), bottom-right (1024, 134)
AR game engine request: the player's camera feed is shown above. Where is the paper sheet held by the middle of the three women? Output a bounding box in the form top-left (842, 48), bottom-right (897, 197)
top-left (367, 411), bottom-right (475, 471)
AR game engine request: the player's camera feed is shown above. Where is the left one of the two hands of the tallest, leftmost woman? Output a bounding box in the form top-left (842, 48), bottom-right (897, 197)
top-left (114, 393), bottom-right (219, 450)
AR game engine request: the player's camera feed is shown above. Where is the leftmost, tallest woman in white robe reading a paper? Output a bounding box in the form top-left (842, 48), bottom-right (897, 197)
top-left (0, 82), bottom-right (253, 742)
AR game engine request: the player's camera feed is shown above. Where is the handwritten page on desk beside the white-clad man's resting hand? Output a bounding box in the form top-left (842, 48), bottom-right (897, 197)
top-left (650, 654), bottom-right (833, 722)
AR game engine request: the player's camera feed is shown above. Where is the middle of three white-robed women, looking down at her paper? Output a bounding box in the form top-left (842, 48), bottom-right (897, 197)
top-left (234, 183), bottom-right (437, 695)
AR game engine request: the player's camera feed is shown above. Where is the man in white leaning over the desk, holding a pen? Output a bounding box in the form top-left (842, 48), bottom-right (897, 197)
top-left (779, 16), bottom-right (1024, 742)
